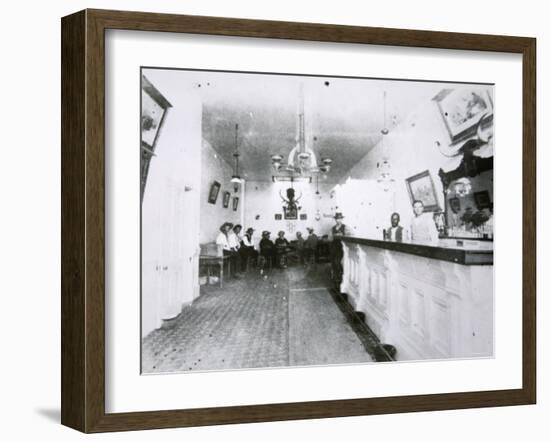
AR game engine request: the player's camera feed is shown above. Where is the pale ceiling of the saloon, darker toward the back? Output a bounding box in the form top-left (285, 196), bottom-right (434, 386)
top-left (146, 70), bottom-right (444, 182)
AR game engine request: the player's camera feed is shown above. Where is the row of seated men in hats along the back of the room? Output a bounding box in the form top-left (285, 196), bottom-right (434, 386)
top-left (216, 222), bottom-right (319, 277)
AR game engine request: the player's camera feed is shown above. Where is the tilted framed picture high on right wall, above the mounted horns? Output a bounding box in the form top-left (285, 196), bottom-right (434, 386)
top-left (434, 88), bottom-right (493, 143)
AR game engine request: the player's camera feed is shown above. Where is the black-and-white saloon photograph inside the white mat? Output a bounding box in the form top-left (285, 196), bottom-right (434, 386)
top-left (141, 69), bottom-right (494, 373)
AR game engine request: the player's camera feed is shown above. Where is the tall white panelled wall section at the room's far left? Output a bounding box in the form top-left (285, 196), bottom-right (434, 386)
top-left (141, 75), bottom-right (202, 336)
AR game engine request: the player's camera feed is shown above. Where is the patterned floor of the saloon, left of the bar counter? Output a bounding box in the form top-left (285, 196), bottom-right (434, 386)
top-left (142, 265), bottom-right (372, 373)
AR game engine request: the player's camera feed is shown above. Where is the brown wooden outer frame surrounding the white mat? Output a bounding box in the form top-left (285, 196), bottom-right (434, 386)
top-left (61, 10), bottom-right (536, 432)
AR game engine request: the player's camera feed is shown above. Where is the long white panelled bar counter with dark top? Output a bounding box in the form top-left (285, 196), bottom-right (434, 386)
top-left (340, 236), bottom-right (494, 360)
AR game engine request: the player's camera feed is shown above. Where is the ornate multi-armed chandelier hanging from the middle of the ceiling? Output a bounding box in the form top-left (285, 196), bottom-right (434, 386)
top-left (271, 84), bottom-right (332, 177)
